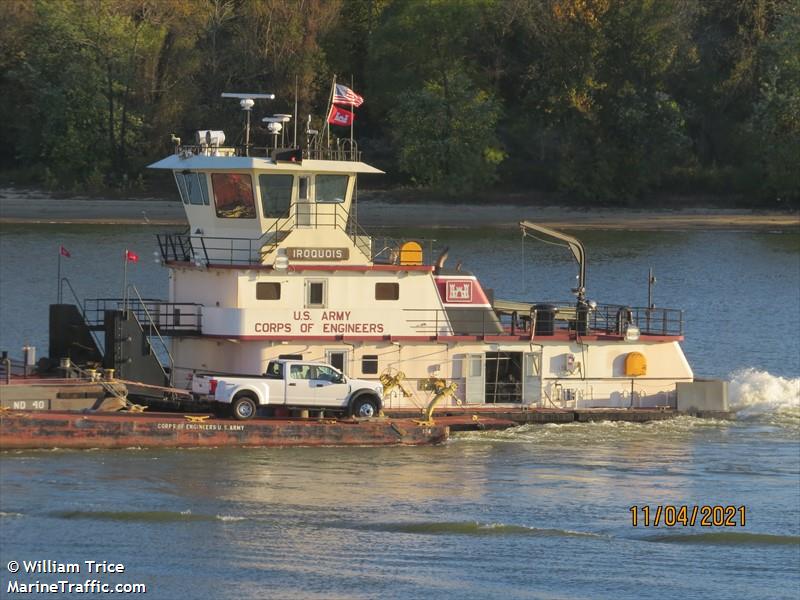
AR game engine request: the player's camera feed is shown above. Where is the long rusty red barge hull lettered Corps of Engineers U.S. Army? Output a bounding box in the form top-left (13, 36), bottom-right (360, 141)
top-left (0, 411), bottom-right (449, 450)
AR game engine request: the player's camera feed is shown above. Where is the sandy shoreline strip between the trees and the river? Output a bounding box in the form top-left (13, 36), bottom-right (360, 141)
top-left (0, 188), bottom-right (800, 231)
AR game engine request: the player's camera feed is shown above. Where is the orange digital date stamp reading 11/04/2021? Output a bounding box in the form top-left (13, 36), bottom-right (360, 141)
top-left (628, 504), bottom-right (747, 527)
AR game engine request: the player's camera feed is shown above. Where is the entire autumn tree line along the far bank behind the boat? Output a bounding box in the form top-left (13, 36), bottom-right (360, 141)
top-left (0, 0), bottom-right (800, 205)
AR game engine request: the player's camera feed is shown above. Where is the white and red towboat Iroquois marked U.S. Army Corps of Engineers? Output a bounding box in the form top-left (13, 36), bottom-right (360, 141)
top-left (42, 94), bottom-right (721, 410)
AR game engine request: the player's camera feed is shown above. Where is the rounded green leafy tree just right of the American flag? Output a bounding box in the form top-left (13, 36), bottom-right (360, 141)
top-left (368, 0), bottom-right (504, 194)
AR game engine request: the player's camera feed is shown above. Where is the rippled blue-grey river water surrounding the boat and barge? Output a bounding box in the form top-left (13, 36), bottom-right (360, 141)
top-left (0, 226), bottom-right (800, 599)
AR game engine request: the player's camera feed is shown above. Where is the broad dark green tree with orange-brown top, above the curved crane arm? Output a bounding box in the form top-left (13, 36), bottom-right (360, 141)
top-left (496, 0), bottom-right (689, 200)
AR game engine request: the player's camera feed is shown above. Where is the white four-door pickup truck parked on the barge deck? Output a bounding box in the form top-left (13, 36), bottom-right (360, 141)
top-left (192, 359), bottom-right (383, 420)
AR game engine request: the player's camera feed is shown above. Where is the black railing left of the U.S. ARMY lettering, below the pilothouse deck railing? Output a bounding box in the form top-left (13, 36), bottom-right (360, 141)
top-left (83, 296), bottom-right (202, 335)
